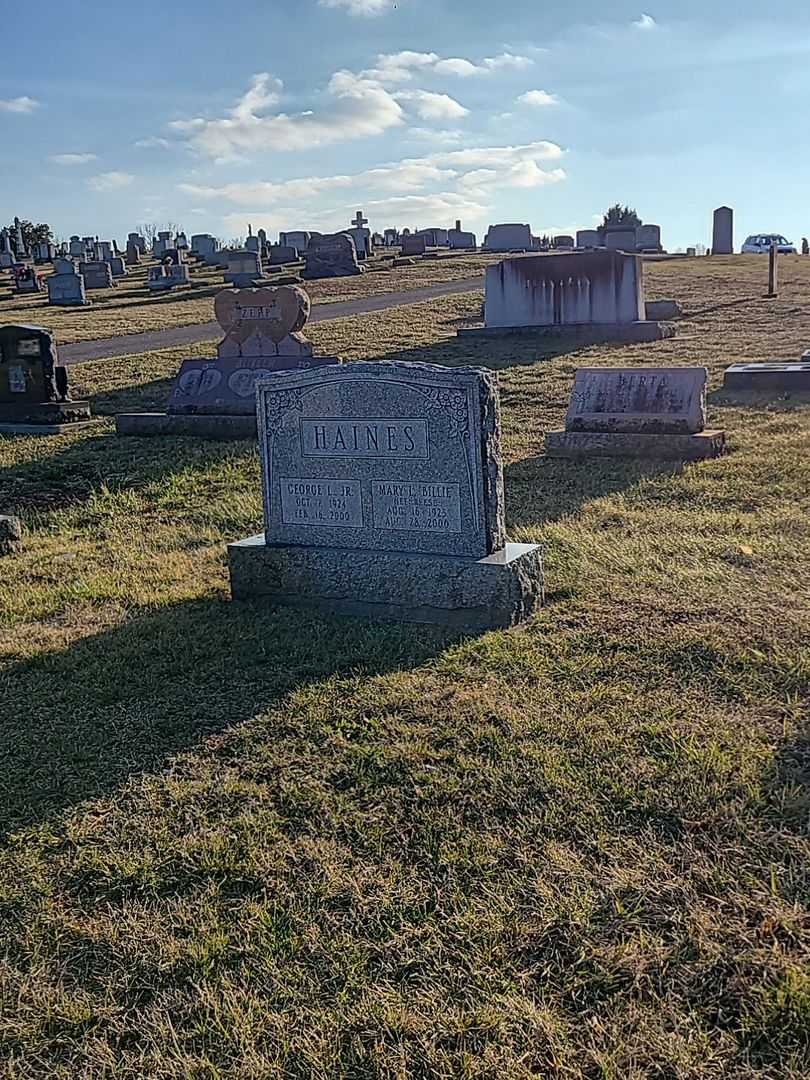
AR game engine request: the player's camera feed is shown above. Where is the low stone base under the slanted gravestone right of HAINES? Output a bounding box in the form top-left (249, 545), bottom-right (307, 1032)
top-left (545, 431), bottom-right (726, 461)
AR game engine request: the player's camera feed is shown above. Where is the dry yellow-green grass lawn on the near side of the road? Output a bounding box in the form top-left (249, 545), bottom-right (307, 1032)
top-left (0, 252), bottom-right (810, 1080)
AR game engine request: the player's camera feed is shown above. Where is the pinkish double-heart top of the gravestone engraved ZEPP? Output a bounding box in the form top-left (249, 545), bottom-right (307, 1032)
top-left (214, 285), bottom-right (310, 345)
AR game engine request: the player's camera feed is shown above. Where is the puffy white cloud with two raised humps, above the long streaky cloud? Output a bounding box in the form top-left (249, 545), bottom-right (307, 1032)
top-left (170, 71), bottom-right (404, 161)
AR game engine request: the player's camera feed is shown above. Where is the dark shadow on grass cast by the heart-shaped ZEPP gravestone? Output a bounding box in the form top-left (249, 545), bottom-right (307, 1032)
top-left (0, 432), bottom-right (257, 515)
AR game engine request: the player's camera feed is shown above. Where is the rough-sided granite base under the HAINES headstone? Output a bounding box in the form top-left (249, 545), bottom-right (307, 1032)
top-left (228, 534), bottom-right (543, 630)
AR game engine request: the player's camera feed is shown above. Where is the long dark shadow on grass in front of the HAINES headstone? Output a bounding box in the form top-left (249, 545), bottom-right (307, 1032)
top-left (0, 599), bottom-right (462, 837)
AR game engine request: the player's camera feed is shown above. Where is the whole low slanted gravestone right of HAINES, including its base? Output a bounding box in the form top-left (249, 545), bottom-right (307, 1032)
top-left (545, 367), bottom-right (726, 461)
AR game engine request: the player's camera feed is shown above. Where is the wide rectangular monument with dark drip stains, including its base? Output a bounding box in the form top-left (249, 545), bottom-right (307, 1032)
top-left (458, 252), bottom-right (675, 341)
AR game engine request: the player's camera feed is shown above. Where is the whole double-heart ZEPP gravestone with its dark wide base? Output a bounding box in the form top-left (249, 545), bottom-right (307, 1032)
top-left (116, 285), bottom-right (339, 438)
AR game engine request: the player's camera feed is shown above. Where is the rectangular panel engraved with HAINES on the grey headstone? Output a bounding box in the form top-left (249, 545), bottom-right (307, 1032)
top-left (300, 417), bottom-right (430, 461)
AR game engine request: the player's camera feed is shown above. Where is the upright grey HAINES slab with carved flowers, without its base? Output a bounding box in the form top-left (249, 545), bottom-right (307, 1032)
top-left (256, 362), bottom-right (505, 558)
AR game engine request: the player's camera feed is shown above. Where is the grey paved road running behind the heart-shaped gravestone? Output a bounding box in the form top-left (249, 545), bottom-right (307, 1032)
top-left (58, 275), bottom-right (484, 364)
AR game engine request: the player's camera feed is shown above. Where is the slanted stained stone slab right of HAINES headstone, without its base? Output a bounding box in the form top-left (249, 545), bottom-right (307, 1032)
top-left (565, 367), bottom-right (708, 435)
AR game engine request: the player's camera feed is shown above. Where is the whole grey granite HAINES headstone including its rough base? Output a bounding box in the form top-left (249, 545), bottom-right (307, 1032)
top-left (228, 363), bottom-right (543, 629)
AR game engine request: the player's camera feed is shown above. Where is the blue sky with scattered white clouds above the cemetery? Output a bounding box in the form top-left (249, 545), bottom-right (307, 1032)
top-left (0, 0), bottom-right (810, 248)
